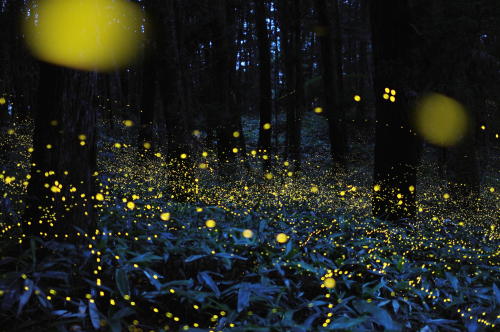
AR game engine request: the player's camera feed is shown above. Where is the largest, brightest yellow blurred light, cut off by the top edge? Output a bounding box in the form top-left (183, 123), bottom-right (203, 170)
top-left (23, 0), bottom-right (143, 71)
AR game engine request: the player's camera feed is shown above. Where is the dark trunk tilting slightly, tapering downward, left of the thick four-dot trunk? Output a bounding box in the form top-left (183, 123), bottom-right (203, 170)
top-left (315, 0), bottom-right (347, 167)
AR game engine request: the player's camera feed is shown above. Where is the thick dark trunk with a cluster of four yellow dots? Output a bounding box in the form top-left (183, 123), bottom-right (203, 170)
top-left (370, 0), bottom-right (418, 221)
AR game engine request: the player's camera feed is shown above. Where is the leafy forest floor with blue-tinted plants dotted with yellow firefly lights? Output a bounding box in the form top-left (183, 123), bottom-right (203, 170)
top-left (0, 117), bottom-right (500, 332)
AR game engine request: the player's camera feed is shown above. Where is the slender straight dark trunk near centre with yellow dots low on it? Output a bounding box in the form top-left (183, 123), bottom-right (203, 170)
top-left (255, 1), bottom-right (272, 170)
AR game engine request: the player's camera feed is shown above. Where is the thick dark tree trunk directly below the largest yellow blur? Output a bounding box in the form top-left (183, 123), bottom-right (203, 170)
top-left (24, 63), bottom-right (96, 241)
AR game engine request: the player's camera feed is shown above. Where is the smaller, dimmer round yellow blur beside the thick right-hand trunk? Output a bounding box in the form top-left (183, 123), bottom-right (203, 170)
top-left (415, 93), bottom-right (468, 146)
